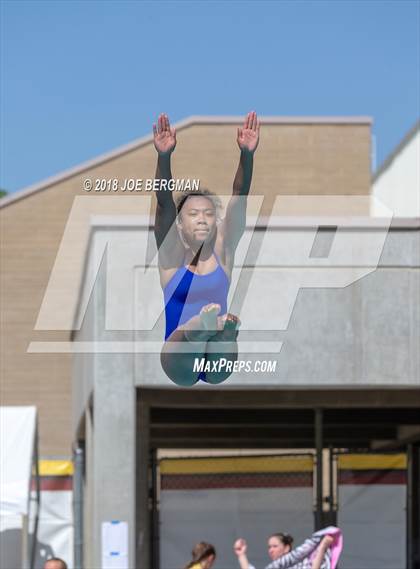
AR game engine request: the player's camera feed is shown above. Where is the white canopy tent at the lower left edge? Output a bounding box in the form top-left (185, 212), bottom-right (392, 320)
top-left (0, 407), bottom-right (39, 569)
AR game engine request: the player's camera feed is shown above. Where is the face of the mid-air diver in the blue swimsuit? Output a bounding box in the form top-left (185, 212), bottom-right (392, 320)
top-left (179, 196), bottom-right (216, 246)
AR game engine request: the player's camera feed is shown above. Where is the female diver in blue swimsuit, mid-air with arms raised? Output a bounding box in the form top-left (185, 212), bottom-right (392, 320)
top-left (153, 112), bottom-right (259, 386)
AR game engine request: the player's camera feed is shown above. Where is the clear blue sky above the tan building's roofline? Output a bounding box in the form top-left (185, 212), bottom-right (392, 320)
top-left (0, 0), bottom-right (420, 192)
